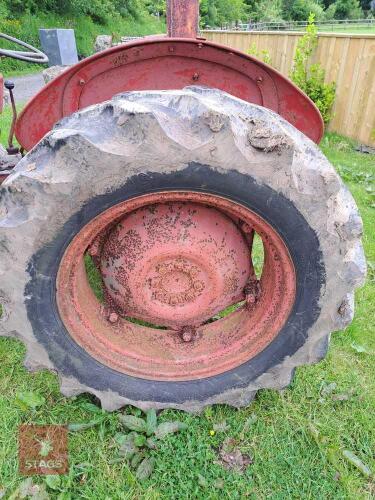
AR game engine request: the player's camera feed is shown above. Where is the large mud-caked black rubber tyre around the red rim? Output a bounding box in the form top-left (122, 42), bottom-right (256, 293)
top-left (0, 87), bottom-right (366, 411)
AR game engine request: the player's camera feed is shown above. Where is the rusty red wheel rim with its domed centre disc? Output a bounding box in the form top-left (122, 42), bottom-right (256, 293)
top-left (56, 191), bottom-right (296, 381)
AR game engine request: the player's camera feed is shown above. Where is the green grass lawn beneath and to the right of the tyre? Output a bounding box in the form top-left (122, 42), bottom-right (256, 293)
top-left (0, 118), bottom-right (375, 500)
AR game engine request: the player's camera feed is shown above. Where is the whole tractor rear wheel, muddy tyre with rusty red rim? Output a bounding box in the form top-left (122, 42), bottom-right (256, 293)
top-left (0, 87), bottom-right (365, 411)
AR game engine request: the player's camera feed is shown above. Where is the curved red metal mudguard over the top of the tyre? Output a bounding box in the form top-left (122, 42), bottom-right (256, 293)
top-left (16, 37), bottom-right (323, 150)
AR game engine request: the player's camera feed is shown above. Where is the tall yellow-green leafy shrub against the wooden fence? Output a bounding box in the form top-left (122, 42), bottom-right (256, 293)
top-left (289, 14), bottom-right (336, 123)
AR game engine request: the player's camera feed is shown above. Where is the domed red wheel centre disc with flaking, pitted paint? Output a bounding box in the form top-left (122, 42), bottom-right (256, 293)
top-left (100, 202), bottom-right (251, 328)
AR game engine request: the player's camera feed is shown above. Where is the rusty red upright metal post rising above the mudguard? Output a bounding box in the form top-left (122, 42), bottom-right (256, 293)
top-left (167, 0), bottom-right (199, 38)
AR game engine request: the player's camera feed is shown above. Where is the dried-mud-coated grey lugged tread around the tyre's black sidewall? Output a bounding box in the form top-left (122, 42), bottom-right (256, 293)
top-left (0, 87), bottom-right (366, 412)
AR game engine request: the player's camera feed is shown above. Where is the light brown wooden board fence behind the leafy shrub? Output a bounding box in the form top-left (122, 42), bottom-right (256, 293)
top-left (203, 31), bottom-right (375, 146)
